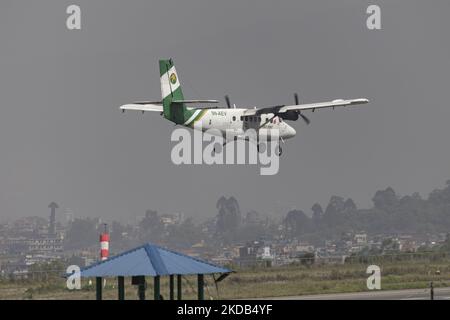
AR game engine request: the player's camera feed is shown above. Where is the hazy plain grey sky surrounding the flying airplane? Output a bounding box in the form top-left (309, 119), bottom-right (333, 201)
top-left (0, 0), bottom-right (450, 221)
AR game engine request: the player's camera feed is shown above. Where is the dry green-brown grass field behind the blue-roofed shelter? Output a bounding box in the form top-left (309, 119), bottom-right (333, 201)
top-left (0, 259), bottom-right (450, 299)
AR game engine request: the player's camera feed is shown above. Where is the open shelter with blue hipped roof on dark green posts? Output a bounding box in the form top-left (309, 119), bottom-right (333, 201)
top-left (81, 243), bottom-right (232, 300)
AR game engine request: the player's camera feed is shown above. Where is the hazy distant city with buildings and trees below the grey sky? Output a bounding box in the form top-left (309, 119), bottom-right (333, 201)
top-left (0, 180), bottom-right (450, 278)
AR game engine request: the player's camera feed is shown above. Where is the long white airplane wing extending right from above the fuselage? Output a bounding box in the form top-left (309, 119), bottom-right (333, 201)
top-left (244, 99), bottom-right (369, 116)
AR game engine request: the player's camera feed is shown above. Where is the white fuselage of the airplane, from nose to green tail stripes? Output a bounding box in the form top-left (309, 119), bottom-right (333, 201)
top-left (186, 108), bottom-right (296, 140)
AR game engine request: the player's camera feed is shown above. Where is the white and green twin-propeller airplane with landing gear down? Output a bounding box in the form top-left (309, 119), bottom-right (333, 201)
top-left (120, 59), bottom-right (369, 156)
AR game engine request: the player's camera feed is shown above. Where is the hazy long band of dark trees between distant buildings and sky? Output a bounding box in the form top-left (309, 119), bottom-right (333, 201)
top-left (57, 180), bottom-right (450, 252)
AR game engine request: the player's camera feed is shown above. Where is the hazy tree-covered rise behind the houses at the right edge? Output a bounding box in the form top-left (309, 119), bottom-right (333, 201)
top-left (283, 180), bottom-right (450, 244)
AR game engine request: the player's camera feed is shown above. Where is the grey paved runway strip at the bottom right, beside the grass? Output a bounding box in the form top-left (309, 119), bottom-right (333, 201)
top-left (265, 287), bottom-right (450, 300)
